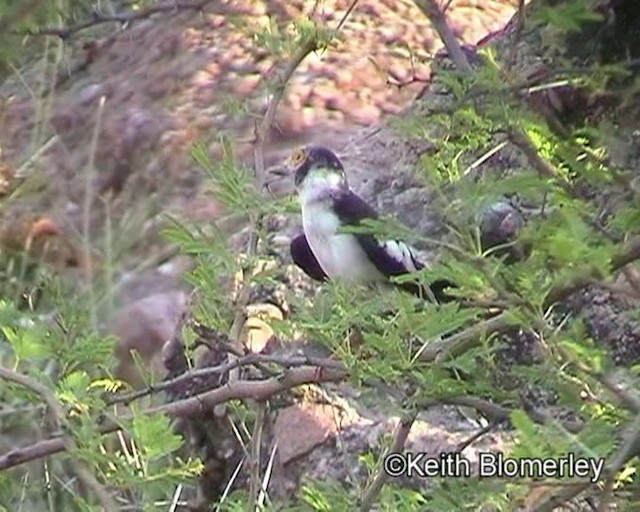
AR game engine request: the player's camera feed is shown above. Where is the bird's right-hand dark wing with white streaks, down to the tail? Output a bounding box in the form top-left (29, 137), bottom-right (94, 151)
top-left (333, 191), bottom-right (453, 302)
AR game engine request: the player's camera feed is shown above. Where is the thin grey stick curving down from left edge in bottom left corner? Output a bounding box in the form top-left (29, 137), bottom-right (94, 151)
top-left (0, 366), bottom-right (118, 512)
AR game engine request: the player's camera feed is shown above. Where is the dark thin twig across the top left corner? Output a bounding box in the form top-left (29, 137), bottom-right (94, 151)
top-left (14, 0), bottom-right (220, 41)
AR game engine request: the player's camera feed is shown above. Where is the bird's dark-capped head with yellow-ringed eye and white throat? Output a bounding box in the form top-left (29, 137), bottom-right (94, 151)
top-left (285, 146), bottom-right (348, 199)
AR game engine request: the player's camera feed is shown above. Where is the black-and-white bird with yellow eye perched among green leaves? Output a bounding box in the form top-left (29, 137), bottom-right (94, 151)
top-left (275, 145), bottom-right (453, 302)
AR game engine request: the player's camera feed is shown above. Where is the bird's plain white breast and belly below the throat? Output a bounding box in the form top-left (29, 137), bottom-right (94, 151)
top-left (302, 201), bottom-right (384, 282)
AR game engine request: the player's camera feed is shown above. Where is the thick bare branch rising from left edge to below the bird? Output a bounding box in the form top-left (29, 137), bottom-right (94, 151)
top-left (0, 366), bottom-right (347, 471)
